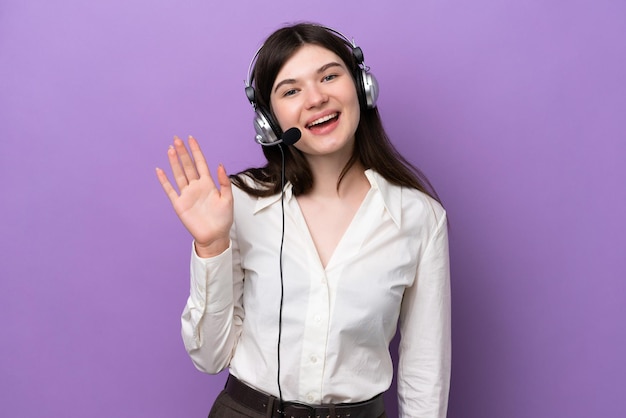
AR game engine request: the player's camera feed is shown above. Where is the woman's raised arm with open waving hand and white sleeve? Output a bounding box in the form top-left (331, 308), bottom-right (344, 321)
top-left (156, 137), bottom-right (244, 373)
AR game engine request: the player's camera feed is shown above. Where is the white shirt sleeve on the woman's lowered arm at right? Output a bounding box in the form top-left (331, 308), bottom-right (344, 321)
top-left (398, 212), bottom-right (451, 418)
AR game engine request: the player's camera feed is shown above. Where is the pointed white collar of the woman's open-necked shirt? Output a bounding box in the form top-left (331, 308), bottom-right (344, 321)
top-left (254, 169), bottom-right (402, 227)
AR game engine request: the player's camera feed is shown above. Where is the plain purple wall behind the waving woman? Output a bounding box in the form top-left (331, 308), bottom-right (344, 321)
top-left (0, 0), bottom-right (626, 418)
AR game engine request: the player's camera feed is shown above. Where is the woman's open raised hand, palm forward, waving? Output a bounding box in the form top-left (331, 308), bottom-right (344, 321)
top-left (156, 136), bottom-right (233, 257)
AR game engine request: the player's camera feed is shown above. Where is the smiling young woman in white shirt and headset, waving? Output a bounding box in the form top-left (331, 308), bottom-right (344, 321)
top-left (157, 24), bottom-right (450, 418)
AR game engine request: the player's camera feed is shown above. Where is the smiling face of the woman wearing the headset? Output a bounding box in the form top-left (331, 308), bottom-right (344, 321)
top-left (270, 45), bottom-right (360, 162)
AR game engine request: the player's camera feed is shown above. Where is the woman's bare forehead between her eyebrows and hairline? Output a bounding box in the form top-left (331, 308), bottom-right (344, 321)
top-left (274, 44), bottom-right (346, 85)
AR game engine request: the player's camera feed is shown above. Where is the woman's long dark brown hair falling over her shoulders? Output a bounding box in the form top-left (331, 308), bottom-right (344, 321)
top-left (231, 23), bottom-right (440, 201)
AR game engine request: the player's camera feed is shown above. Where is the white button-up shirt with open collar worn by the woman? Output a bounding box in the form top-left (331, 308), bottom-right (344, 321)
top-left (182, 170), bottom-right (450, 418)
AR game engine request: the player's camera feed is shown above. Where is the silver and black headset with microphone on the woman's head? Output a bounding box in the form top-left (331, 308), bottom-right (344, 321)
top-left (245, 25), bottom-right (379, 146)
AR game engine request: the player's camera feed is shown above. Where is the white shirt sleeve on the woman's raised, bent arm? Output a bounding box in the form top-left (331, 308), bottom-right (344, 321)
top-left (181, 220), bottom-right (244, 374)
